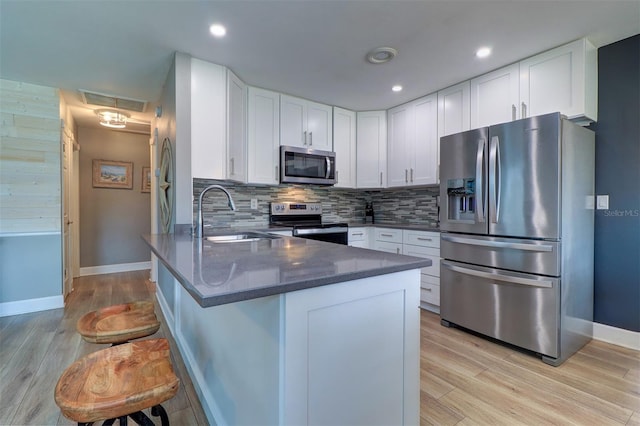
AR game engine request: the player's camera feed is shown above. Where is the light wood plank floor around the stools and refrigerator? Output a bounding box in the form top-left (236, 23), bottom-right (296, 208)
top-left (0, 271), bottom-right (640, 426)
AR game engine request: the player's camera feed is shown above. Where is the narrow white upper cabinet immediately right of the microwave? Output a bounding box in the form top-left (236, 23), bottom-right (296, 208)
top-left (333, 107), bottom-right (356, 188)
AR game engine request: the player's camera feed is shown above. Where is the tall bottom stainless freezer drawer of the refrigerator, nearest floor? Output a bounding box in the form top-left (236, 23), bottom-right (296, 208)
top-left (440, 260), bottom-right (560, 358)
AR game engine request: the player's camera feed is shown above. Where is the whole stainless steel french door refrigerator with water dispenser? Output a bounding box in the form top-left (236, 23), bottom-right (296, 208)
top-left (440, 113), bottom-right (595, 365)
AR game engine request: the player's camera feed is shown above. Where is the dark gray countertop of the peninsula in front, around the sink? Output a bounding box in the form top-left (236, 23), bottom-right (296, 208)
top-left (143, 231), bottom-right (431, 307)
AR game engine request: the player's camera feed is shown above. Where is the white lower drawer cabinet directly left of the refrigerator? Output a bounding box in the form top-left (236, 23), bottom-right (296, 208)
top-left (402, 229), bottom-right (440, 312)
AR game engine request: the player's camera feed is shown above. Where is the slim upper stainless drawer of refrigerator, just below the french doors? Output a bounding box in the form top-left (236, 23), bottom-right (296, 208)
top-left (440, 234), bottom-right (561, 277)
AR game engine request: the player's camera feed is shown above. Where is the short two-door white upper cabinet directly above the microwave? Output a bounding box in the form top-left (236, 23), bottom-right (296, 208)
top-left (280, 95), bottom-right (333, 151)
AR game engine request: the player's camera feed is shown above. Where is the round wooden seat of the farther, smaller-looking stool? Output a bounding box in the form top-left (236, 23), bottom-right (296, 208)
top-left (76, 301), bottom-right (160, 344)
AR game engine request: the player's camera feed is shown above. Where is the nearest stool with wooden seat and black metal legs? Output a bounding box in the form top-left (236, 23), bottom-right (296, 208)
top-left (55, 339), bottom-right (180, 425)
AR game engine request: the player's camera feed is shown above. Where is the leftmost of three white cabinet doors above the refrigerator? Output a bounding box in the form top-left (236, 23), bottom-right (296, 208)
top-left (438, 81), bottom-right (471, 138)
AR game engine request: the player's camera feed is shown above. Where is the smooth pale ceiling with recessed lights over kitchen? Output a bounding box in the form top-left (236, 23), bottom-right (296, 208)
top-left (0, 0), bottom-right (640, 132)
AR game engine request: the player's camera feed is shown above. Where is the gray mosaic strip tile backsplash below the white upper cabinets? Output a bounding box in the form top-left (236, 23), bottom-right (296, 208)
top-left (193, 179), bottom-right (439, 228)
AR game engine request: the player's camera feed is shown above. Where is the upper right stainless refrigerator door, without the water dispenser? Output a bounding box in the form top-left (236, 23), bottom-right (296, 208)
top-left (488, 113), bottom-right (560, 239)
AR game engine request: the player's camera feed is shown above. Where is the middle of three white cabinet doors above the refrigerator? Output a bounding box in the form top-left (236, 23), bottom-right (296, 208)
top-left (471, 64), bottom-right (520, 129)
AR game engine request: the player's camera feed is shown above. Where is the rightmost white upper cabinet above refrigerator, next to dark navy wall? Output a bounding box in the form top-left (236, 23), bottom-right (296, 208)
top-left (520, 39), bottom-right (598, 122)
